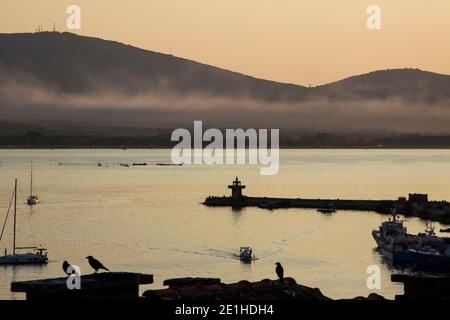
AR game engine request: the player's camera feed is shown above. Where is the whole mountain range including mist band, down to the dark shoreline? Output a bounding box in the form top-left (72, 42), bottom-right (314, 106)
top-left (0, 32), bottom-right (450, 132)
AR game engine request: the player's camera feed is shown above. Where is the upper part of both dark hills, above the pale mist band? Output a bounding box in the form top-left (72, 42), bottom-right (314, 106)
top-left (0, 32), bottom-right (450, 102)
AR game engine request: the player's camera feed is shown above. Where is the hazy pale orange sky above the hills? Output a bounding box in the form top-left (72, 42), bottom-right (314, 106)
top-left (0, 0), bottom-right (450, 85)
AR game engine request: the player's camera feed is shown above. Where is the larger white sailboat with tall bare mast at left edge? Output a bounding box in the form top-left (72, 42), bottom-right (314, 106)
top-left (0, 179), bottom-right (48, 265)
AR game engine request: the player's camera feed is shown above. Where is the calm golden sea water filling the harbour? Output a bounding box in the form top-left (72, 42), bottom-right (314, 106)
top-left (0, 150), bottom-right (450, 299)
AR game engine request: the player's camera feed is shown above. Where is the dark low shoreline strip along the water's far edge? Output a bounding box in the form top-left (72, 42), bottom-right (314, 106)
top-left (0, 123), bottom-right (450, 149)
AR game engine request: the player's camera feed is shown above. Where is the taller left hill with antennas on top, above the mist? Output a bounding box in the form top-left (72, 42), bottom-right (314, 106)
top-left (0, 32), bottom-right (306, 99)
